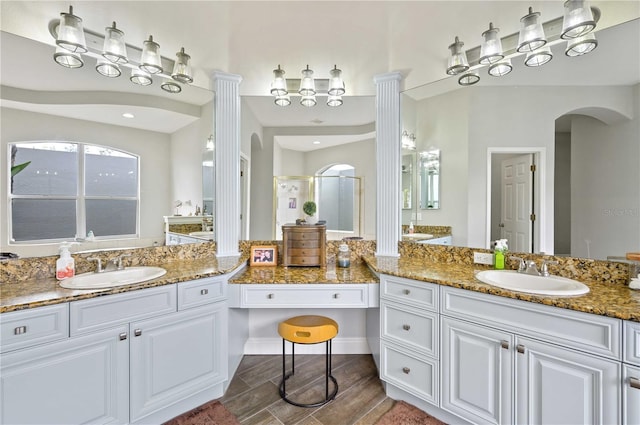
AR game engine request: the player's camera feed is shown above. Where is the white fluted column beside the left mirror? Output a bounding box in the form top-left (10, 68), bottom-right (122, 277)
top-left (213, 72), bottom-right (242, 257)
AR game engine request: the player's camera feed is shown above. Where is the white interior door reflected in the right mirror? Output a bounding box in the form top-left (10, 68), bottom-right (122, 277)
top-left (500, 154), bottom-right (533, 252)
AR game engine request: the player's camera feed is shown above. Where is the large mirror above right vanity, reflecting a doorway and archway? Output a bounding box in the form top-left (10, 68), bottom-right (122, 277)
top-left (402, 19), bottom-right (640, 259)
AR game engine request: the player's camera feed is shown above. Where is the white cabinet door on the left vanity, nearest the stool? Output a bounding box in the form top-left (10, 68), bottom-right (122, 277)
top-left (130, 303), bottom-right (227, 422)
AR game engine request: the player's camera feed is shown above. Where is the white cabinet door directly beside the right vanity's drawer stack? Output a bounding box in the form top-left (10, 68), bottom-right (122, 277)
top-left (441, 316), bottom-right (514, 424)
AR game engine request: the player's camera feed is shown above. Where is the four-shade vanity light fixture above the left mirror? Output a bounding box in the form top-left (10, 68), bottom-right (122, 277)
top-left (49, 6), bottom-right (193, 93)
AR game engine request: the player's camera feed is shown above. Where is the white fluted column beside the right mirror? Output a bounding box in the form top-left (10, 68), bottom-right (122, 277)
top-left (373, 72), bottom-right (402, 257)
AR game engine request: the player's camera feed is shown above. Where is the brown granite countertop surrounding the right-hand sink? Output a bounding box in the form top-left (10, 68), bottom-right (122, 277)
top-left (364, 256), bottom-right (640, 322)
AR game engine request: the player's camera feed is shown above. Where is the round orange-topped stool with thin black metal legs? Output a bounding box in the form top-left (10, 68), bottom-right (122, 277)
top-left (278, 315), bottom-right (338, 407)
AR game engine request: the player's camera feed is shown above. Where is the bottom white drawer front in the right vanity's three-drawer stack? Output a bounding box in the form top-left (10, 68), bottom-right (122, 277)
top-left (380, 343), bottom-right (439, 405)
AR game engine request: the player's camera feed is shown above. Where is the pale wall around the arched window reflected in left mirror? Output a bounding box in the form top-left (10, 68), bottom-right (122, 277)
top-left (0, 108), bottom-right (171, 257)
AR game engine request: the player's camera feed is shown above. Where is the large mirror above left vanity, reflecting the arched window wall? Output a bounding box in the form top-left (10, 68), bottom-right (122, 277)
top-left (0, 31), bottom-right (215, 257)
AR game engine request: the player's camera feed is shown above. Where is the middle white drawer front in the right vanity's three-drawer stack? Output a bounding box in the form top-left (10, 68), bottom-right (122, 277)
top-left (380, 301), bottom-right (439, 358)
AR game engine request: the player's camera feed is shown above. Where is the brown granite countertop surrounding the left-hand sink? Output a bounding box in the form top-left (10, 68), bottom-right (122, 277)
top-left (0, 256), bottom-right (247, 313)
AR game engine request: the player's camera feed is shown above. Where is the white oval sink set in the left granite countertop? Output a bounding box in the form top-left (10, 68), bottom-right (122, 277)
top-left (60, 267), bottom-right (167, 289)
